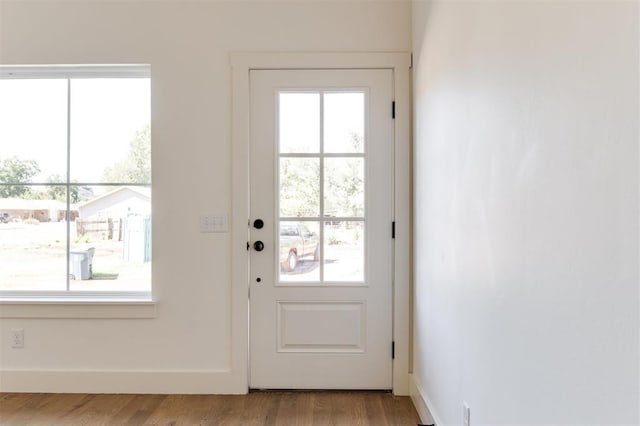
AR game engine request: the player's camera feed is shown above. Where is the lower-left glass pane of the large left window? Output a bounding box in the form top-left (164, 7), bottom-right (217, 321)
top-left (0, 186), bottom-right (67, 291)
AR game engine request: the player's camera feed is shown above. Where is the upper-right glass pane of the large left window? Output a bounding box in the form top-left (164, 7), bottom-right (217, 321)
top-left (71, 78), bottom-right (151, 183)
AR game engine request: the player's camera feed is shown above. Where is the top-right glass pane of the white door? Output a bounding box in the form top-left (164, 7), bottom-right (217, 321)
top-left (324, 92), bottom-right (365, 153)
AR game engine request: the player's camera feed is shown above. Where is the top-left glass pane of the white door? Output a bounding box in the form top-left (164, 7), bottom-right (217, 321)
top-left (279, 93), bottom-right (320, 153)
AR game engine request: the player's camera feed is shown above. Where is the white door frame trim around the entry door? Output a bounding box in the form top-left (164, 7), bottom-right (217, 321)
top-left (229, 52), bottom-right (411, 395)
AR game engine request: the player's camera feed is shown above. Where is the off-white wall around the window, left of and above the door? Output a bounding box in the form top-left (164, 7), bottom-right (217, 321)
top-left (0, 1), bottom-right (411, 392)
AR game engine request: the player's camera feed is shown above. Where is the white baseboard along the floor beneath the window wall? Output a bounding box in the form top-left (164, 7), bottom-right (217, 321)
top-left (0, 370), bottom-right (248, 394)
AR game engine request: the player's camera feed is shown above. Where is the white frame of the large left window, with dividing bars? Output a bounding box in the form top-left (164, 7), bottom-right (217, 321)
top-left (0, 64), bottom-right (155, 304)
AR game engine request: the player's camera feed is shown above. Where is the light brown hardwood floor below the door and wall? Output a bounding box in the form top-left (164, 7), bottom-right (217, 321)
top-left (0, 391), bottom-right (419, 426)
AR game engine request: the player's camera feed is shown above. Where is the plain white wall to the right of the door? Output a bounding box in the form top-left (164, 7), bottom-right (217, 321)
top-left (413, 1), bottom-right (640, 426)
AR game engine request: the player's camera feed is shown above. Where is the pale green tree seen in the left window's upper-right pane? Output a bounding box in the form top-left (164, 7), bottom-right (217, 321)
top-left (102, 125), bottom-right (151, 183)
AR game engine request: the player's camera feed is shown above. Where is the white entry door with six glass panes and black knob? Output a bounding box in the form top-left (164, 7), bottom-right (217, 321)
top-left (249, 69), bottom-right (394, 389)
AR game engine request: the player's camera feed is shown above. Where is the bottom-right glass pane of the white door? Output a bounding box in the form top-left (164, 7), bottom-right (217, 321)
top-left (324, 221), bottom-right (365, 282)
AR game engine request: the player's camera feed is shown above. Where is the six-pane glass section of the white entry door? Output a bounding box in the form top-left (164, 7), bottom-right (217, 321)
top-left (277, 92), bottom-right (366, 285)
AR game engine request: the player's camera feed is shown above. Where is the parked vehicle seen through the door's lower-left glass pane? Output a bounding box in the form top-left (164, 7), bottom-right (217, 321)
top-left (280, 222), bottom-right (319, 272)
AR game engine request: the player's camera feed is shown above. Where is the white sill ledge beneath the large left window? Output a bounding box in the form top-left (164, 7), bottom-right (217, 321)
top-left (0, 298), bottom-right (156, 319)
